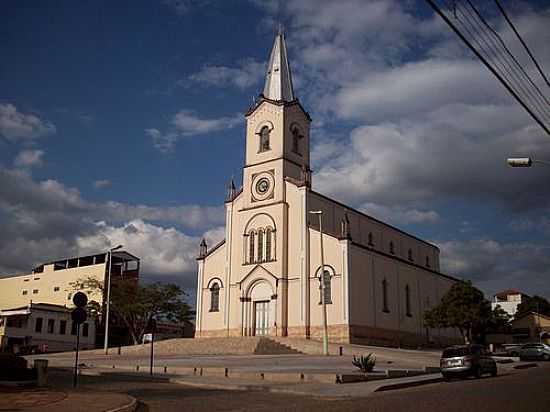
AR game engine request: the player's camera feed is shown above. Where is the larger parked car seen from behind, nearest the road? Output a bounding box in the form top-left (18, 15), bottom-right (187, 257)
top-left (440, 344), bottom-right (497, 380)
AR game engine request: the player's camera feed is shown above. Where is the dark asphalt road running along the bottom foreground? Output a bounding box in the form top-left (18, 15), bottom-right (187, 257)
top-left (48, 363), bottom-right (550, 412)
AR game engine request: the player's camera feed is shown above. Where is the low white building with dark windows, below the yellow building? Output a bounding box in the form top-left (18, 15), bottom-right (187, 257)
top-left (0, 303), bottom-right (95, 352)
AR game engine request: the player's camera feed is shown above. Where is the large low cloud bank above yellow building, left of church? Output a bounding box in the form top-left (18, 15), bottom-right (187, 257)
top-left (0, 169), bottom-right (224, 282)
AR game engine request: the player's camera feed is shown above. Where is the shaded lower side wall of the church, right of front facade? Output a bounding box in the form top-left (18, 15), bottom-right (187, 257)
top-left (349, 244), bottom-right (460, 347)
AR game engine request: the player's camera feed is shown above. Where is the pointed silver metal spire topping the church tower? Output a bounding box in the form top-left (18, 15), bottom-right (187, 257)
top-left (263, 27), bottom-right (295, 102)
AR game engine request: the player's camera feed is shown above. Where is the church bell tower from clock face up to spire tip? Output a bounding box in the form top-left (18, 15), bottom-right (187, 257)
top-left (243, 30), bottom-right (311, 206)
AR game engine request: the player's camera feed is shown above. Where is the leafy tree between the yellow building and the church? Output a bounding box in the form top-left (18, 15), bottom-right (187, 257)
top-left (71, 277), bottom-right (195, 344)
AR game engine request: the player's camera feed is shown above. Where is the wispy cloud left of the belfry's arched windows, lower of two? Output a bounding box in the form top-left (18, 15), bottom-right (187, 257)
top-left (145, 110), bottom-right (243, 153)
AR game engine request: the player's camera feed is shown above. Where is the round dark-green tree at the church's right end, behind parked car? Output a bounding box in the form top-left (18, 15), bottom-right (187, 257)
top-left (424, 281), bottom-right (499, 343)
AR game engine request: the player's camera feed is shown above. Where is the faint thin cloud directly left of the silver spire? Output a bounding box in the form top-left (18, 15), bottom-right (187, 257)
top-left (187, 58), bottom-right (265, 89)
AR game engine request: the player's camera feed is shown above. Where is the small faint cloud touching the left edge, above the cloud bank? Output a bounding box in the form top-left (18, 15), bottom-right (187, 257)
top-left (0, 103), bottom-right (56, 141)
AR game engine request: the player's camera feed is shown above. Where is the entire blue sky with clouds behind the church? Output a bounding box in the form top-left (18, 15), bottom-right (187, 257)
top-left (0, 0), bottom-right (550, 297)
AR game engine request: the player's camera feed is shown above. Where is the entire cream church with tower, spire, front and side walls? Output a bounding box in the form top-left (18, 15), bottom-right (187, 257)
top-left (196, 34), bottom-right (464, 346)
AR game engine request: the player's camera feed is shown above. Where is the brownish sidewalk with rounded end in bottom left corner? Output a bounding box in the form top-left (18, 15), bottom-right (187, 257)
top-left (0, 388), bottom-right (137, 412)
